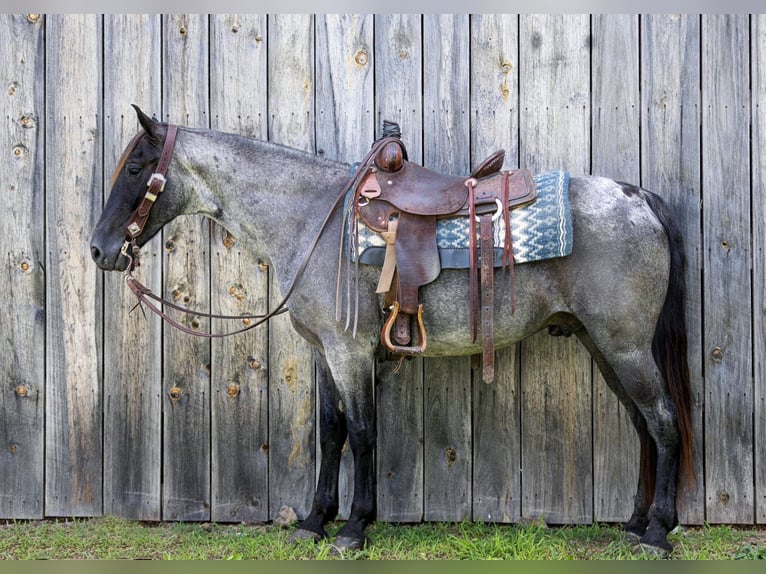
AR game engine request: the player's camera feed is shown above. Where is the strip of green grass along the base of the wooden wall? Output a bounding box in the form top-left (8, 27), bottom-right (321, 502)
top-left (0, 517), bottom-right (766, 560)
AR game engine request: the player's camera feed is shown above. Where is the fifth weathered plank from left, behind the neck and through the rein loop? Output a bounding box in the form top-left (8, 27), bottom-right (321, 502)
top-left (210, 14), bottom-right (269, 522)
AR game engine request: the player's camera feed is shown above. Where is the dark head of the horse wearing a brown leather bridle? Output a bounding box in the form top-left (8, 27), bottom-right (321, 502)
top-left (91, 105), bottom-right (185, 271)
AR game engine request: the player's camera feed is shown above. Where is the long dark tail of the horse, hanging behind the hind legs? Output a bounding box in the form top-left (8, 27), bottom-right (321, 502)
top-left (642, 190), bottom-right (695, 496)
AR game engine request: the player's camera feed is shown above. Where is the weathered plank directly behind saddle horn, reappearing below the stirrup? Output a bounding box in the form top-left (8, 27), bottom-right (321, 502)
top-left (375, 14), bottom-right (423, 522)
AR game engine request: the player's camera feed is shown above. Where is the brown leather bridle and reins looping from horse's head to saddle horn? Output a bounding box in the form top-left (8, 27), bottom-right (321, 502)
top-left (112, 124), bottom-right (371, 338)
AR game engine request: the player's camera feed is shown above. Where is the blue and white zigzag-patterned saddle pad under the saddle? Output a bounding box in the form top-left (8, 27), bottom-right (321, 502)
top-left (346, 171), bottom-right (573, 269)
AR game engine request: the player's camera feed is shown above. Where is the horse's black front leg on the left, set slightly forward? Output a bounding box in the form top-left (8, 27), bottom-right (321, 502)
top-left (291, 350), bottom-right (348, 541)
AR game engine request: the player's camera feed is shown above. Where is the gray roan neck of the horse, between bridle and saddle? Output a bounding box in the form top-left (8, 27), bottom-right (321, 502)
top-left (175, 130), bottom-right (348, 281)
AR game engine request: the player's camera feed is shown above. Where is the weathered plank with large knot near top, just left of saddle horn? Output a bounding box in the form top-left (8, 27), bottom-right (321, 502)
top-left (316, 14), bottom-right (375, 518)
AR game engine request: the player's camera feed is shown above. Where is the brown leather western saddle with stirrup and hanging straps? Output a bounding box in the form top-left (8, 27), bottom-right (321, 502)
top-left (342, 122), bottom-right (537, 382)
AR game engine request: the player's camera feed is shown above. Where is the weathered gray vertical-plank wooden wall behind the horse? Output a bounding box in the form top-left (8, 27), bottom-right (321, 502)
top-left (0, 14), bottom-right (766, 524)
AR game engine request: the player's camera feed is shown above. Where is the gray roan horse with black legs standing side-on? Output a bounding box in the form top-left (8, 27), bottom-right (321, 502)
top-left (91, 108), bottom-right (694, 553)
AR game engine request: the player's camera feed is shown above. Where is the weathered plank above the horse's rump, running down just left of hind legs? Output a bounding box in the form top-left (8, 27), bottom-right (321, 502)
top-left (592, 14), bottom-right (641, 522)
